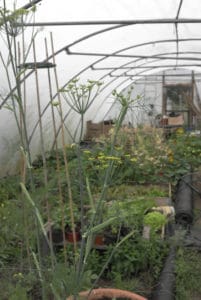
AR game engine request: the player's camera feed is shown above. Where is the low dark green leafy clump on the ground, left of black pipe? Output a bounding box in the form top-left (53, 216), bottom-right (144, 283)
top-left (87, 232), bottom-right (169, 284)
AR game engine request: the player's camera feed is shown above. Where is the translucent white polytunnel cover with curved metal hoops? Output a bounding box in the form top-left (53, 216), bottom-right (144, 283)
top-left (0, 0), bottom-right (201, 175)
